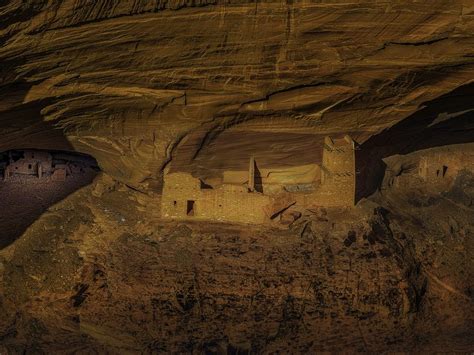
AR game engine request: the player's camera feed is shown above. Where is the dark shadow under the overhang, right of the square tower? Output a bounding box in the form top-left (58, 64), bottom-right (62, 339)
top-left (356, 83), bottom-right (474, 202)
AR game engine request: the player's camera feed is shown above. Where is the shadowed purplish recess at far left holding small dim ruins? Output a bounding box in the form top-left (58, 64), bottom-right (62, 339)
top-left (0, 149), bottom-right (98, 249)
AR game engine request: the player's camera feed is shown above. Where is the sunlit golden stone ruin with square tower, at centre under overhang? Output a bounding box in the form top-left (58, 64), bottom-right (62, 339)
top-left (161, 136), bottom-right (356, 224)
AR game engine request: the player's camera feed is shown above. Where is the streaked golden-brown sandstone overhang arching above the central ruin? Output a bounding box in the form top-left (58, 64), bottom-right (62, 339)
top-left (0, 0), bottom-right (474, 188)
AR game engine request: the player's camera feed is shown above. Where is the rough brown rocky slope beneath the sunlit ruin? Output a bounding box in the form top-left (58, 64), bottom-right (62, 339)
top-left (0, 168), bottom-right (474, 353)
